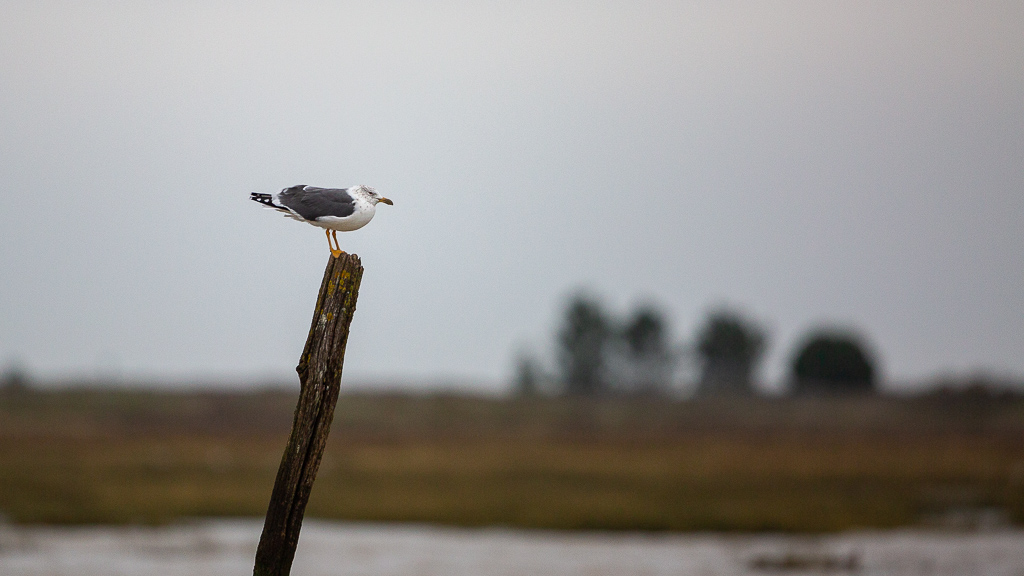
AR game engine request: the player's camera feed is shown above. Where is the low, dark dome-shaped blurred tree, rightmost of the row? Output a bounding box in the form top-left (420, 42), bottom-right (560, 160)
top-left (793, 331), bottom-right (876, 394)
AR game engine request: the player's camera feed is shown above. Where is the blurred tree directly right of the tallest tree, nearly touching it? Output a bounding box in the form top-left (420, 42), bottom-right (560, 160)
top-left (621, 305), bottom-right (675, 395)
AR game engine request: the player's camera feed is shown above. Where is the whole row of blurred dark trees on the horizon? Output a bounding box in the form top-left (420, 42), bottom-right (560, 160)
top-left (515, 295), bottom-right (878, 396)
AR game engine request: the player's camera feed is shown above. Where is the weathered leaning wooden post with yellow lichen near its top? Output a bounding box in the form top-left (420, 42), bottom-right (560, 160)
top-left (253, 254), bottom-right (362, 576)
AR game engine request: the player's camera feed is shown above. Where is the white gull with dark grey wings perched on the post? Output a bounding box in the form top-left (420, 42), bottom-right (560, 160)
top-left (249, 184), bottom-right (394, 258)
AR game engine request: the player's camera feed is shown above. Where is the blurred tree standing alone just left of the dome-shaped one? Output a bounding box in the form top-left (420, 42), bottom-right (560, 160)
top-left (696, 310), bottom-right (766, 395)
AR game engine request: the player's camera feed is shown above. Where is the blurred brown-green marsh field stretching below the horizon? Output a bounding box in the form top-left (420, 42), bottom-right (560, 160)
top-left (0, 390), bottom-right (1024, 531)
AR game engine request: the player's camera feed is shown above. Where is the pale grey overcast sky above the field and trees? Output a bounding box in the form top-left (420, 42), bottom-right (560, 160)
top-left (0, 0), bottom-right (1024, 388)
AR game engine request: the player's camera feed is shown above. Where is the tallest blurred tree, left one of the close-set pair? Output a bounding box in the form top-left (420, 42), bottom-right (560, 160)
top-left (558, 295), bottom-right (609, 396)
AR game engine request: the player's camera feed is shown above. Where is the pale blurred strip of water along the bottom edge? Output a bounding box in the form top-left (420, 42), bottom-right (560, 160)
top-left (0, 520), bottom-right (1024, 576)
